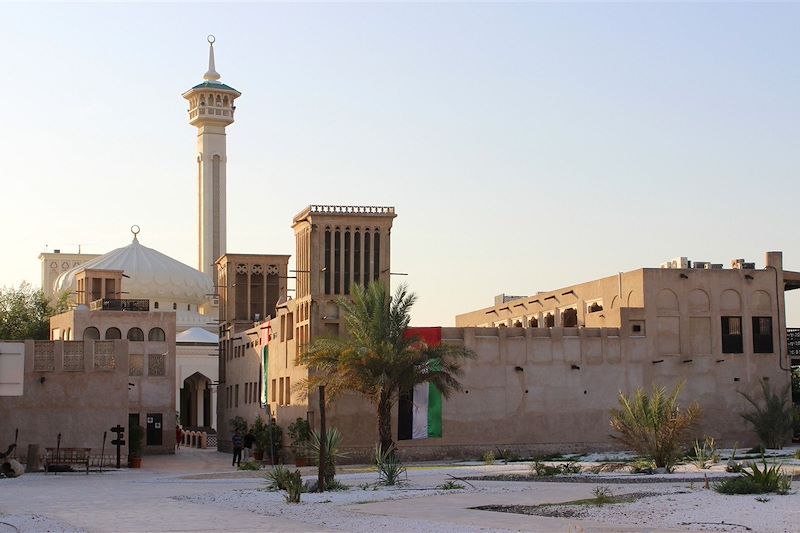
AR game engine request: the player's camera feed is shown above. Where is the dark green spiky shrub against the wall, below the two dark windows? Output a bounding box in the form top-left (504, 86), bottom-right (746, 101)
top-left (739, 380), bottom-right (794, 449)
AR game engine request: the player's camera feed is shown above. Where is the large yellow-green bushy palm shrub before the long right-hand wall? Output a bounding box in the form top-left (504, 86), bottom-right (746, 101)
top-left (611, 383), bottom-right (700, 472)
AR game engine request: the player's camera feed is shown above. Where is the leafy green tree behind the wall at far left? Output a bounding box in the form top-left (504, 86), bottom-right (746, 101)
top-left (0, 281), bottom-right (67, 340)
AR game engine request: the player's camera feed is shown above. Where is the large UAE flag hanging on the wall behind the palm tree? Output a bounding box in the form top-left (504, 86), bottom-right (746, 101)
top-left (397, 328), bottom-right (442, 440)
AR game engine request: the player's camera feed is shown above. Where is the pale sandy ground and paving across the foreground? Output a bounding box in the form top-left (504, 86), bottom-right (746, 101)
top-left (0, 449), bottom-right (800, 533)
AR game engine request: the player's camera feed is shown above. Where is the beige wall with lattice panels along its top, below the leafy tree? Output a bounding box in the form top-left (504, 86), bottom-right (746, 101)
top-left (0, 341), bottom-right (128, 456)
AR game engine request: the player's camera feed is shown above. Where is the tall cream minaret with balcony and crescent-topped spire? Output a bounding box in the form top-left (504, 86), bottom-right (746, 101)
top-left (183, 35), bottom-right (242, 279)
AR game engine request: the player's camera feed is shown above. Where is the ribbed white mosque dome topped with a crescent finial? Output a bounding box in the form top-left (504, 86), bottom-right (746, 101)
top-left (53, 237), bottom-right (214, 305)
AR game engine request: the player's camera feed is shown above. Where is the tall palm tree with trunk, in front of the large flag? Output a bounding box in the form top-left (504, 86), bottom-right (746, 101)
top-left (298, 283), bottom-right (475, 450)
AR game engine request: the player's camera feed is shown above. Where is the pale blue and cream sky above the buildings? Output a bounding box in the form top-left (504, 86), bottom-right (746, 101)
top-left (0, 3), bottom-right (800, 326)
